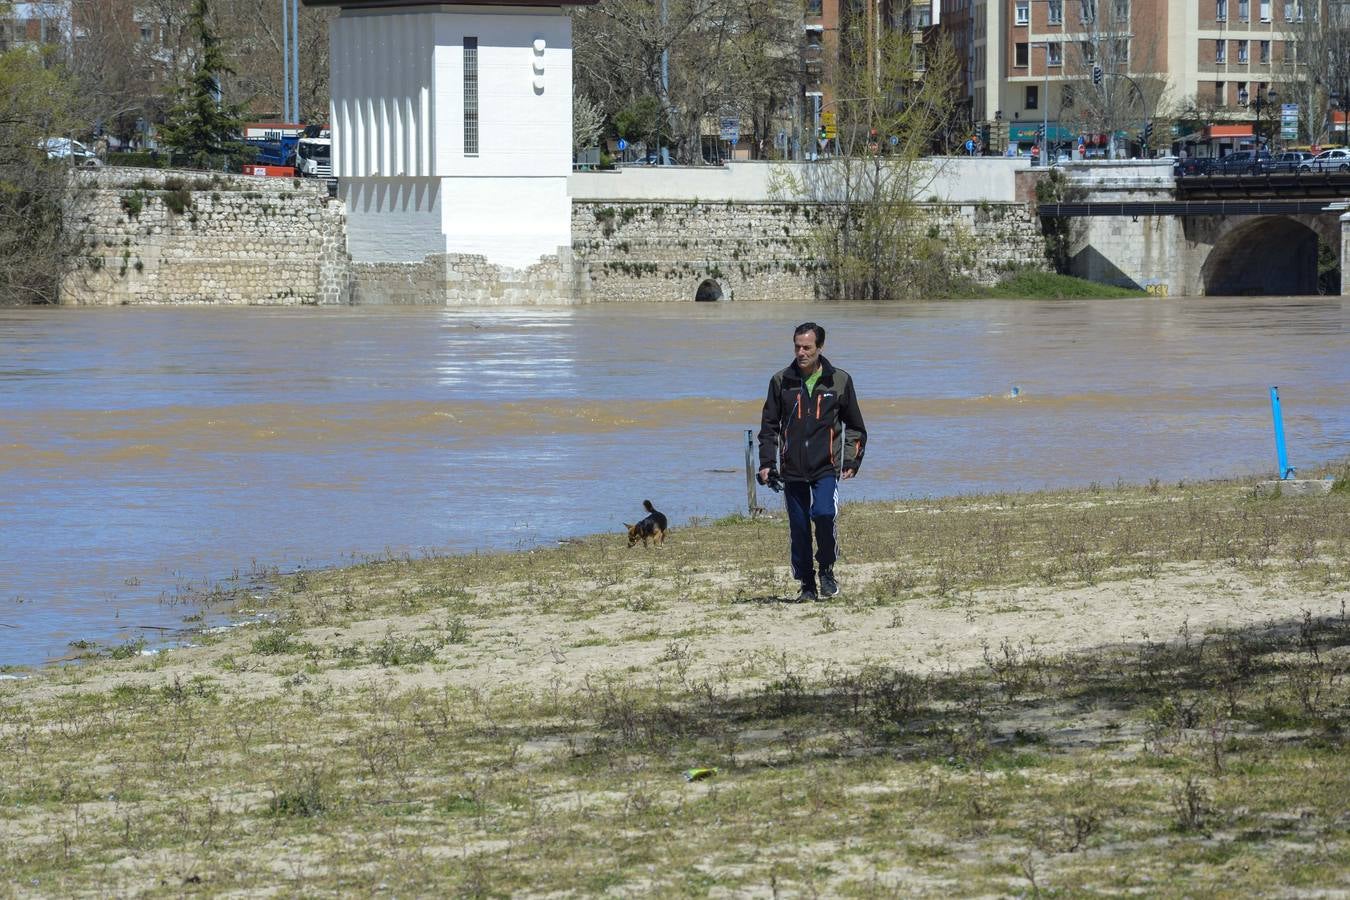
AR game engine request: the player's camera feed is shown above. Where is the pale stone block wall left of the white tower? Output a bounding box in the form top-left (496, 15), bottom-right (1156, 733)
top-left (61, 167), bottom-right (351, 305)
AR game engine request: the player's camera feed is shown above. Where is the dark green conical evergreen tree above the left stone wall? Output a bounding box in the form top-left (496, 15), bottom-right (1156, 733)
top-left (159, 0), bottom-right (250, 169)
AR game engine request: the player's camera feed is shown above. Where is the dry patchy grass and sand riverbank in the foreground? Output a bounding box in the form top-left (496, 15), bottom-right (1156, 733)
top-left (0, 469), bottom-right (1350, 897)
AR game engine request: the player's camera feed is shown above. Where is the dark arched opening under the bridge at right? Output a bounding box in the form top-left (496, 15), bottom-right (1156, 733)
top-left (1200, 216), bottom-right (1320, 296)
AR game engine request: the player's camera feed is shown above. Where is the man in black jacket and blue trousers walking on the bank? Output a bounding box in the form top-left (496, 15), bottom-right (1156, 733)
top-left (759, 322), bottom-right (867, 602)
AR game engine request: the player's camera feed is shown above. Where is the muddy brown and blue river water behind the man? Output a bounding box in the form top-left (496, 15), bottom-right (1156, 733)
top-left (0, 298), bottom-right (1350, 664)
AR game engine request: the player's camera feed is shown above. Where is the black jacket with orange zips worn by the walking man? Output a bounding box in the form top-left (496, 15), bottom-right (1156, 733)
top-left (760, 356), bottom-right (867, 482)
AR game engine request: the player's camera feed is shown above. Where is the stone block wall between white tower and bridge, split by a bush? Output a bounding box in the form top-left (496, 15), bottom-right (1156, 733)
top-left (572, 200), bottom-right (1049, 302)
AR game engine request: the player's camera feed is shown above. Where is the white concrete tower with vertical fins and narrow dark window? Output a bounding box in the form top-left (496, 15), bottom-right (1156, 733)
top-left (304, 0), bottom-right (595, 277)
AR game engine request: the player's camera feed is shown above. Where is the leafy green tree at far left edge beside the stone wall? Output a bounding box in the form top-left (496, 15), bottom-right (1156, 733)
top-left (0, 47), bottom-right (77, 305)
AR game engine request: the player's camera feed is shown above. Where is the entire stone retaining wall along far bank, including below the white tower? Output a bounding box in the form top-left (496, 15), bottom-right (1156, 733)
top-left (62, 169), bottom-right (1046, 305)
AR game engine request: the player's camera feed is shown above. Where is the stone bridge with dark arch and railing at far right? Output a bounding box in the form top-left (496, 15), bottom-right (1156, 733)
top-left (1041, 161), bottom-right (1350, 296)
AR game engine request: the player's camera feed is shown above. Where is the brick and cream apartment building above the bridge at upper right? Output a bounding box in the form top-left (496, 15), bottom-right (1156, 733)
top-left (942, 0), bottom-right (1318, 151)
